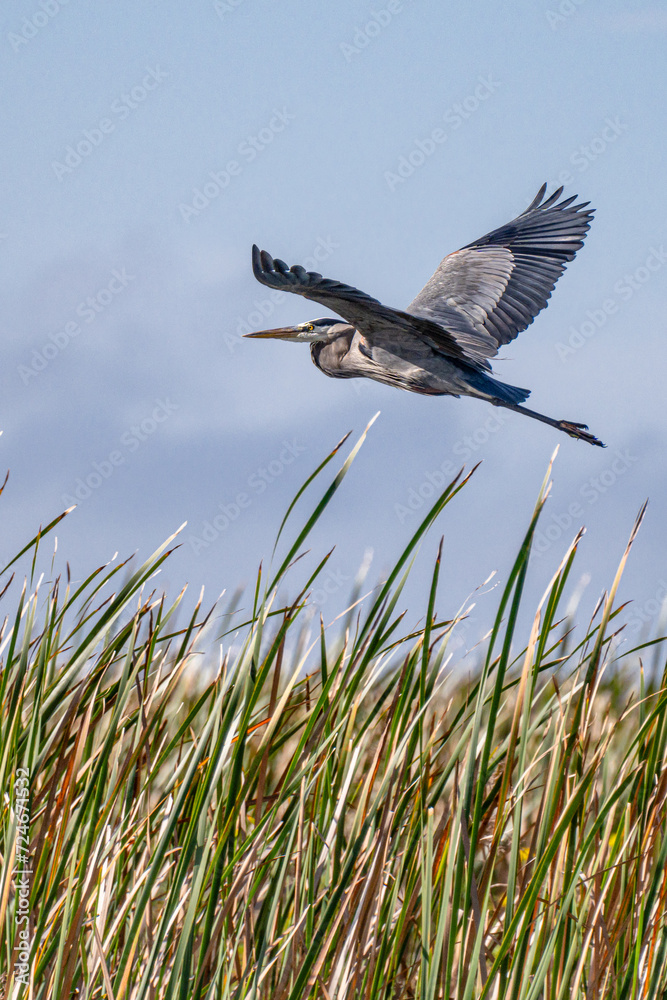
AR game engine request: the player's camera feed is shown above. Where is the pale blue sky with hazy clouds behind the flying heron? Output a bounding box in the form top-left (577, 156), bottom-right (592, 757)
top-left (0, 0), bottom-right (667, 652)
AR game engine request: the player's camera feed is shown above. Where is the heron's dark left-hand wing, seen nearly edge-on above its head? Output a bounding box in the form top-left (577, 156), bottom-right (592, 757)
top-left (252, 246), bottom-right (493, 369)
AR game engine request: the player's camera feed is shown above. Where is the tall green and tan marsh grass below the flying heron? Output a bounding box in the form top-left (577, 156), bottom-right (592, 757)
top-left (0, 426), bottom-right (667, 1000)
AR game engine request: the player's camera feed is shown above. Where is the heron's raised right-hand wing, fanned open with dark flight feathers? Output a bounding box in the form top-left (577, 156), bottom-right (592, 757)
top-left (406, 184), bottom-right (593, 360)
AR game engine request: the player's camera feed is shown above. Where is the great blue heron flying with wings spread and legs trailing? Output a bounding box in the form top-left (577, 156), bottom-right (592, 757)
top-left (246, 184), bottom-right (605, 448)
